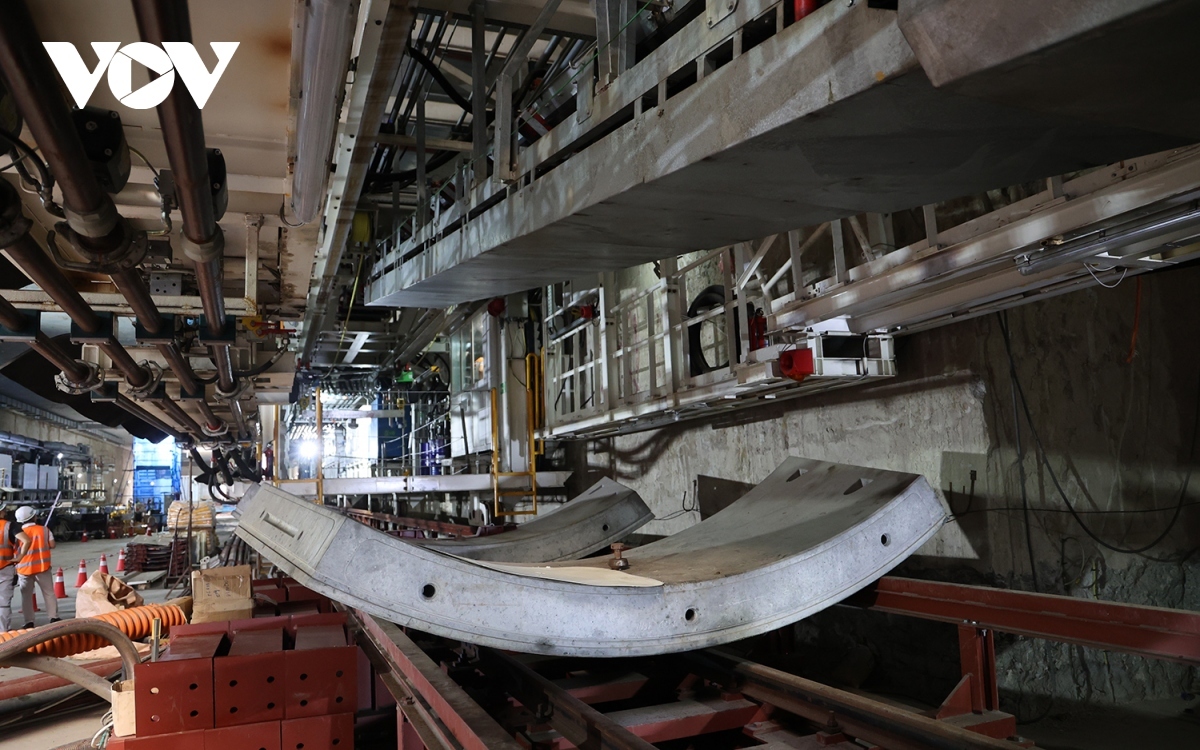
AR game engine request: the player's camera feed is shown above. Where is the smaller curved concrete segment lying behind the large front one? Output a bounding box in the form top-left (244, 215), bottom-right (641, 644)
top-left (410, 478), bottom-right (654, 563)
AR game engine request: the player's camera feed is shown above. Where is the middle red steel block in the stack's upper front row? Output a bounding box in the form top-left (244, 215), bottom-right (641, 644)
top-left (212, 626), bottom-right (284, 727)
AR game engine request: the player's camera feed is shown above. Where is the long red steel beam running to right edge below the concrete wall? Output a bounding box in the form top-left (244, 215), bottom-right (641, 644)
top-left (846, 576), bottom-right (1200, 665)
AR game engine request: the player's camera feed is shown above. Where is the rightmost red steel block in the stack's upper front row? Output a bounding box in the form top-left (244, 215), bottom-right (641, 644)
top-left (283, 625), bottom-right (358, 719)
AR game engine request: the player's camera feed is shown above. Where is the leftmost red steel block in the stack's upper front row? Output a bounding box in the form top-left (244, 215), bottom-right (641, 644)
top-left (134, 634), bottom-right (224, 737)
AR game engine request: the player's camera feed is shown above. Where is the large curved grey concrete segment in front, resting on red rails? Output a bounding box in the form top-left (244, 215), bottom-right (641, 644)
top-left (238, 458), bottom-right (946, 656)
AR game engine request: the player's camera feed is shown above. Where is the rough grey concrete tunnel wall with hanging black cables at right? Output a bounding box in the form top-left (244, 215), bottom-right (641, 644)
top-left (575, 266), bottom-right (1200, 705)
